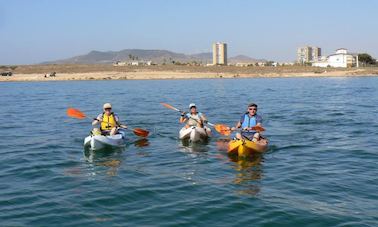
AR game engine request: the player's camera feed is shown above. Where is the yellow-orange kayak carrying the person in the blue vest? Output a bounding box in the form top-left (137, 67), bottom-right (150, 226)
top-left (227, 139), bottom-right (268, 157)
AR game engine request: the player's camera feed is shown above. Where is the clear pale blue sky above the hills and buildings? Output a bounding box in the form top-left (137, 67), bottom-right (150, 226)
top-left (0, 0), bottom-right (378, 65)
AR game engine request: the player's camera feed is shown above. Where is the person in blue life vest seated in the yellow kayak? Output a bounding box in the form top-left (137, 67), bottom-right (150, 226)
top-left (231, 103), bottom-right (262, 142)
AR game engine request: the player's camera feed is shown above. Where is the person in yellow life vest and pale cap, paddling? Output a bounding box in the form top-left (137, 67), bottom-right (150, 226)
top-left (92, 103), bottom-right (127, 135)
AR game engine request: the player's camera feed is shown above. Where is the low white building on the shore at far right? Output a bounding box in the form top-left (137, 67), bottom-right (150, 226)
top-left (312, 48), bottom-right (359, 68)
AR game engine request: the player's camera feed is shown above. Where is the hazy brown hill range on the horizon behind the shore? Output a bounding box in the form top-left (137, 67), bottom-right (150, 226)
top-left (41, 49), bottom-right (266, 64)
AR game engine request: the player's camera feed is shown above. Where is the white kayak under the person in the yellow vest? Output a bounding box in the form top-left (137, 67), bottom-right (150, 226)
top-left (84, 129), bottom-right (126, 150)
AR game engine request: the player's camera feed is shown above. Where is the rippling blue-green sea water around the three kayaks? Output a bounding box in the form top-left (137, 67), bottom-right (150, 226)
top-left (0, 77), bottom-right (378, 226)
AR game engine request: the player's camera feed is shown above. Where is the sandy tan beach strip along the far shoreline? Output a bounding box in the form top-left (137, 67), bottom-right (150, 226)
top-left (0, 65), bottom-right (378, 82)
